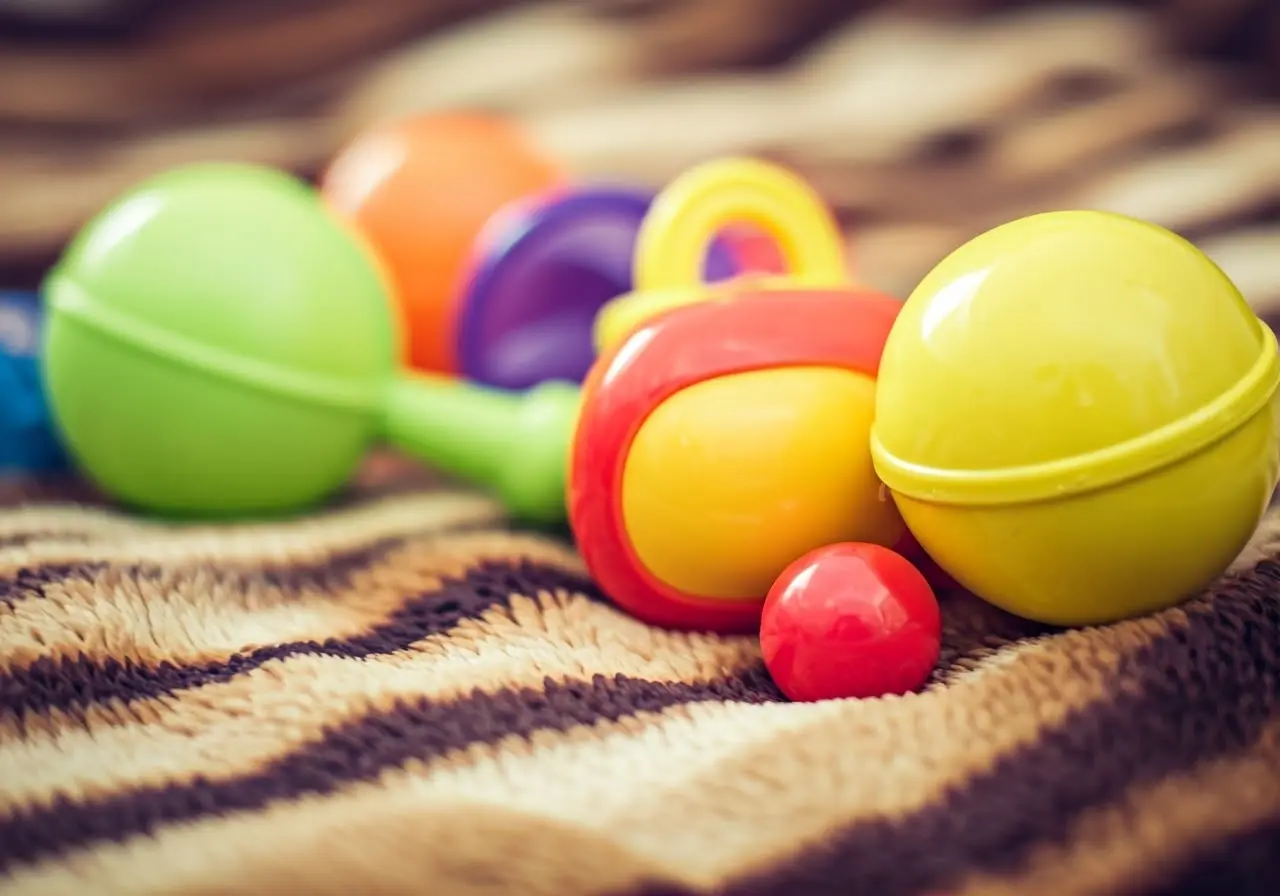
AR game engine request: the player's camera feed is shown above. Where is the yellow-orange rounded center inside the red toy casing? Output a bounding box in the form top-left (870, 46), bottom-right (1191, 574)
top-left (622, 366), bottom-right (901, 600)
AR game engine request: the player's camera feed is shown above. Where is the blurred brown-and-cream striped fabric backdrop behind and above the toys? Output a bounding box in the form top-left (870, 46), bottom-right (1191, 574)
top-left (0, 0), bottom-right (1280, 323)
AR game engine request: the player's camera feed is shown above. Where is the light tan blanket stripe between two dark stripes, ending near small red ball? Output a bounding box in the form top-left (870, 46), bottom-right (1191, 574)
top-left (0, 583), bottom-right (760, 813)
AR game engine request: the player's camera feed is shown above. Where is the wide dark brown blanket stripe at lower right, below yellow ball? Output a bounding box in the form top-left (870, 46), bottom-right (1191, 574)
top-left (629, 561), bottom-right (1280, 896)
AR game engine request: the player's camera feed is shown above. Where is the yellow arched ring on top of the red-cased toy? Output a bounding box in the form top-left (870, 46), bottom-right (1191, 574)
top-left (634, 159), bottom-right (847, 293)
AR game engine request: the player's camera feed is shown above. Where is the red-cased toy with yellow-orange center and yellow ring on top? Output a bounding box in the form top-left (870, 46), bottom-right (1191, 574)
top-left (568, 159), bottom-right (904, 631)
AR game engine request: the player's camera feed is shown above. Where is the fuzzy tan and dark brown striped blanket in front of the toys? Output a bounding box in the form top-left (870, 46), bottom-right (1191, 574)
top-left (0, 468), bottom-right (1280, 896)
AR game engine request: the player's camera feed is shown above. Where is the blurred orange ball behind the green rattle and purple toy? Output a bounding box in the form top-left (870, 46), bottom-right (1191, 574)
top-left (321, 113), bottom-right (562, 374)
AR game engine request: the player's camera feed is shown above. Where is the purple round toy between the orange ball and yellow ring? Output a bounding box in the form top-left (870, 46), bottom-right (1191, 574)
top-left (457, 187), bottom-right (739, 389)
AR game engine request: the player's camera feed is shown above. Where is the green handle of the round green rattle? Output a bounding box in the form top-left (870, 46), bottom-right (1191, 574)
top-left (383, 372), bottom-right (581, 525)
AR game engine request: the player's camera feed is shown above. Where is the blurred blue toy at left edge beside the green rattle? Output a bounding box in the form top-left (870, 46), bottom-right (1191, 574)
top-left (0, 292), bottom-right (67, 474)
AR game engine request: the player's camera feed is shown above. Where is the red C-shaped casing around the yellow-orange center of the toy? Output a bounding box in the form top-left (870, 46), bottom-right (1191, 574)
top-left (567, 287), bottom-right (901, 632)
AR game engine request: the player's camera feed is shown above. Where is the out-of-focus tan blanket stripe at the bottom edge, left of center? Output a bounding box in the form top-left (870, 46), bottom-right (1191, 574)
top-left (9, 794), bottom-right (680, 896)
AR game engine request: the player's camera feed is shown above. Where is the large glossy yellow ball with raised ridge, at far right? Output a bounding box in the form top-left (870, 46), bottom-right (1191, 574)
top-left (872, 211), bottom-right (1280, 625)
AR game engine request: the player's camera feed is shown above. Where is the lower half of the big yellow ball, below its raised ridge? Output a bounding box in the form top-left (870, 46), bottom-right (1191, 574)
top-left (893, 404), bottom-right (1277, 626)
